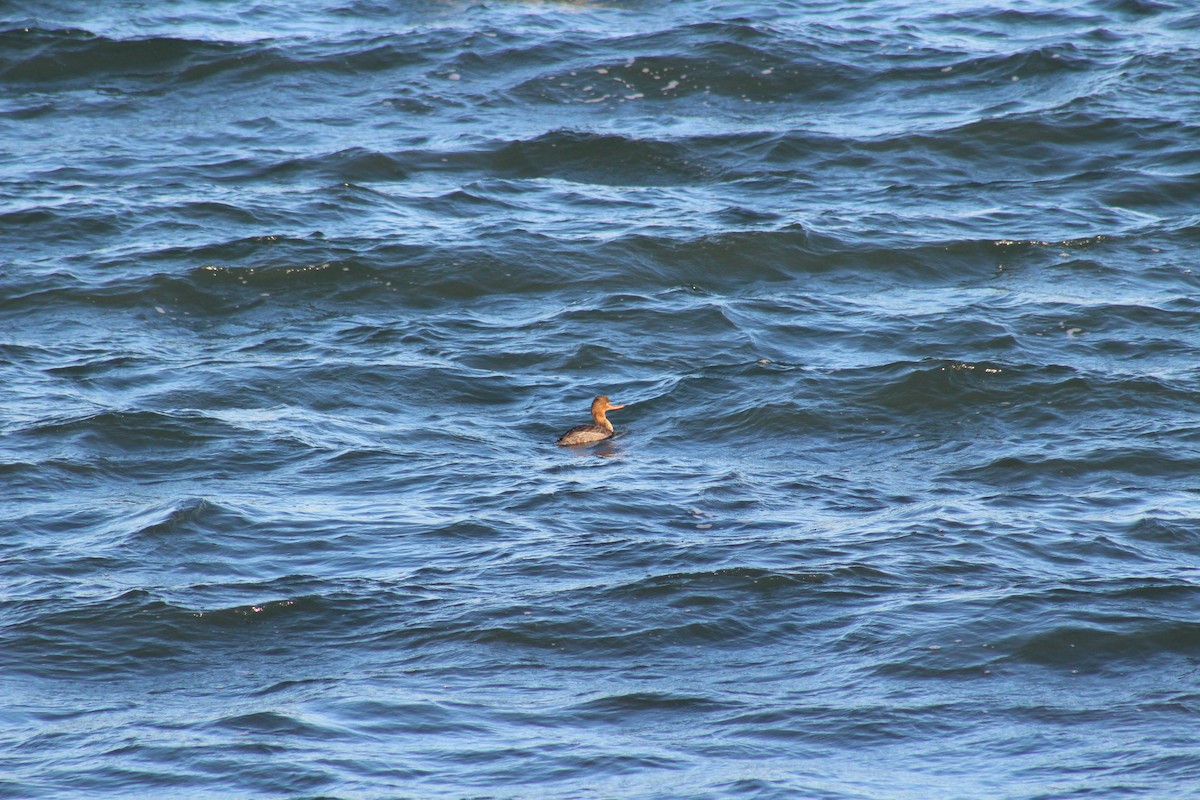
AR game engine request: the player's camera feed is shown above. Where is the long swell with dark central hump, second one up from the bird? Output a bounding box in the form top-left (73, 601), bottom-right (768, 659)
top-left (166, 120), bottom-right (1195, 187)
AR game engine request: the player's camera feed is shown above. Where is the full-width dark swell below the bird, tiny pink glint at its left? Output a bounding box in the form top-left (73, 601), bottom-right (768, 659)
top-left (11, 556), bottom-right (1200, 680)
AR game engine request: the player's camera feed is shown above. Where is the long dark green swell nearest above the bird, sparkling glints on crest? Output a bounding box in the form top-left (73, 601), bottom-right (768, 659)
top-left (0, 224), bottom-right (1161, 318)
